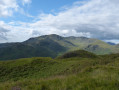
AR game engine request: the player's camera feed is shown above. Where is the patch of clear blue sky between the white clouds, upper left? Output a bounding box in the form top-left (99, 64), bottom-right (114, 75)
top-left (0, 0), bottom-right (80, 22)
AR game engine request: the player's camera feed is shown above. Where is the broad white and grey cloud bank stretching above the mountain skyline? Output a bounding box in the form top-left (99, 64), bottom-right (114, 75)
top-left (0, 0), bottom-right (119, 42)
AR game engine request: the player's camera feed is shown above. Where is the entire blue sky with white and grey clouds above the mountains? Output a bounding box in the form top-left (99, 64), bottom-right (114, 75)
top-left (0, 0), bottom-right (119, 43)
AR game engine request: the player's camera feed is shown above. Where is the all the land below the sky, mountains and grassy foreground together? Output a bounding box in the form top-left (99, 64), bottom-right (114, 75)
top-left (0, 34), bottom-right (119, 90)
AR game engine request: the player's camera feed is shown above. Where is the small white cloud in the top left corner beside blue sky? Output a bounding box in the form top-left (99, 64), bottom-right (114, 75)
top-left (0, 0), bottom-right (31, 17)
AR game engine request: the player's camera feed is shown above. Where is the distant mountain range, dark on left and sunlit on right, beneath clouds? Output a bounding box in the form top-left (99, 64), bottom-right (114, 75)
top-left (0, 34), bottom-right (119, 60)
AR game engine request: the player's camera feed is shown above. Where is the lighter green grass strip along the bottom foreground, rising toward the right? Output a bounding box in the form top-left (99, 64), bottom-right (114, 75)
top-left (0, 67), bottom-right (119, 90)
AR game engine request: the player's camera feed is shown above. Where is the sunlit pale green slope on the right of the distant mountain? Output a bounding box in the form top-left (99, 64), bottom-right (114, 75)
top-left (66, 37), bottom-right (119, 55)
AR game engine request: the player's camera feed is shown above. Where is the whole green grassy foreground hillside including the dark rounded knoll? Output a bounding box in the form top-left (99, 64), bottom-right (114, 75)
top-left (0, 50), bottom-right (119, 90)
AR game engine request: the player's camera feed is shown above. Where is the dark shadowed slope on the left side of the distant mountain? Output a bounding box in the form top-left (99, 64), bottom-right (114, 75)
top-left (0, 40), bottom-right (66, 60)
